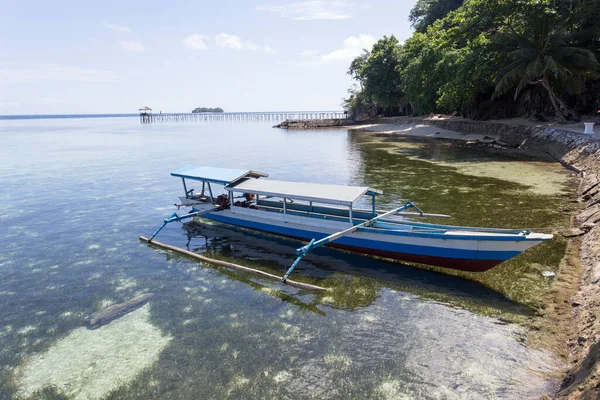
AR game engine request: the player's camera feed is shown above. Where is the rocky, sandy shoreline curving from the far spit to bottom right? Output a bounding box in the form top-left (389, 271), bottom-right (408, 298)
top-left (275, 116), bottom-right (600, 400)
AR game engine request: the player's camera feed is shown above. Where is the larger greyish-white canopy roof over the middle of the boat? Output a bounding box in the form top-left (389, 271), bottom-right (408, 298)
top-left (225, 179), bottom-right (382, 206)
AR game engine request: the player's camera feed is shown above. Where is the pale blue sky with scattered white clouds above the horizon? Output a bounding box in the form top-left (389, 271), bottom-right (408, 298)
top-left (0, 0), bottom-right (416, 115)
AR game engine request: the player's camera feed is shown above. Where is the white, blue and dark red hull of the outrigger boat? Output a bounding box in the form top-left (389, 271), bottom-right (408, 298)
top-left (193, 207), bottom-right (548, 272)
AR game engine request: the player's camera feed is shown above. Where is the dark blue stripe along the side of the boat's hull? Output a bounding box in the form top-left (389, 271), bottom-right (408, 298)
top-left (202, 214), bottom-right (520, 271)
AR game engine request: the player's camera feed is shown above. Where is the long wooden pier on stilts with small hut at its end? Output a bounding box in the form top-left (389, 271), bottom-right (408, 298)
top-left (140, 111), bottom-right (348, 124)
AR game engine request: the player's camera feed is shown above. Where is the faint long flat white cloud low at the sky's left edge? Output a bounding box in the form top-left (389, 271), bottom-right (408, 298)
top-left (0, 64), bottom-right (116, 84)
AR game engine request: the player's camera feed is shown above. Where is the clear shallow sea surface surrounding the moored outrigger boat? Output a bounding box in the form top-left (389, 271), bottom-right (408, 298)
top-left (0, 117), bottom-right (573, 399)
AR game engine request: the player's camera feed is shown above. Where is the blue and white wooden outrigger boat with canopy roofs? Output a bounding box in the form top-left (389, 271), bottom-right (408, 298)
top-left (149, 166), bottom-right (553, 282)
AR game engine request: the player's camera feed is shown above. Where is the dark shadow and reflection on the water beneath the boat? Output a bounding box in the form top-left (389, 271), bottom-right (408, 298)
top-left (183, 221), bottom-right (533, 316)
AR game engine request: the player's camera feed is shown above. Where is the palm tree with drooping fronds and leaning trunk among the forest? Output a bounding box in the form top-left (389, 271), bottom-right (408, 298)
top-left (494, 13), bottom-right (598, 122)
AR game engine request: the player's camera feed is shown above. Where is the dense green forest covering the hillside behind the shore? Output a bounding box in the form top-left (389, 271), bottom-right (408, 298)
top-left (344, 0), bottom-right (600, 121)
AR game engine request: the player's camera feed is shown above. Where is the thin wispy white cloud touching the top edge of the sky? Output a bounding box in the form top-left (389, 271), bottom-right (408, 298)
top-left (256, 0), bottom-right (356, 20)
